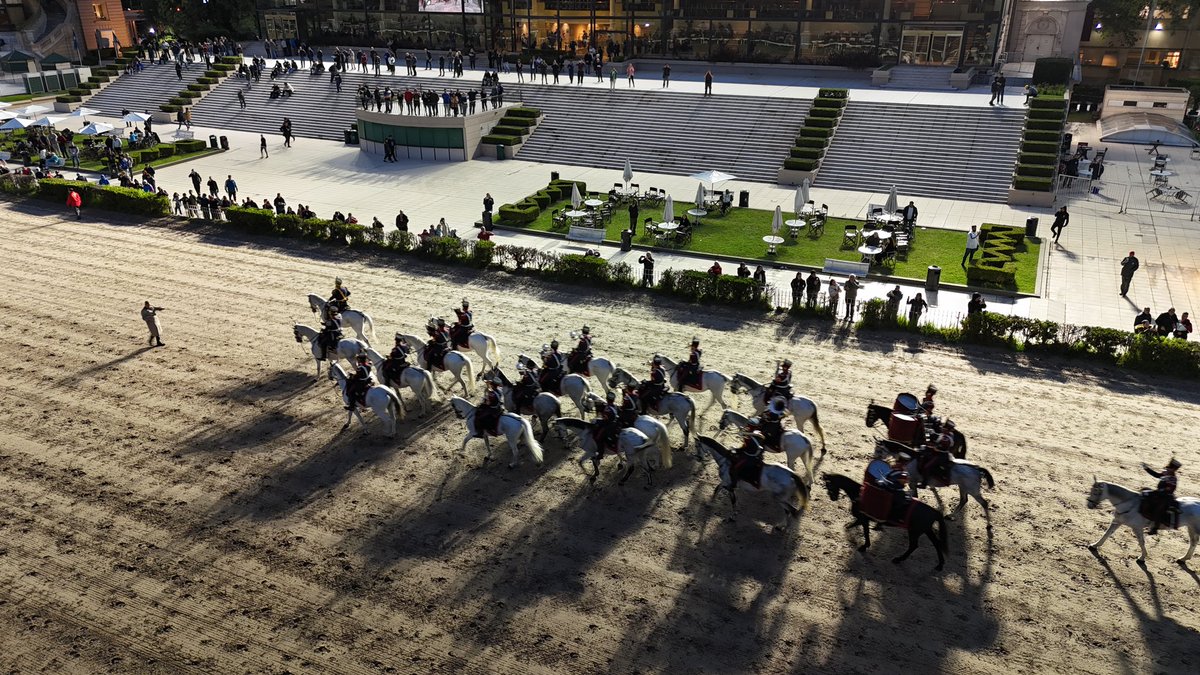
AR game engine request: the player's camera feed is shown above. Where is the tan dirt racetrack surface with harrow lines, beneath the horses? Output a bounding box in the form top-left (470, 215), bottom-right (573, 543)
top-left (0, 208), bottom-right (1200, 675)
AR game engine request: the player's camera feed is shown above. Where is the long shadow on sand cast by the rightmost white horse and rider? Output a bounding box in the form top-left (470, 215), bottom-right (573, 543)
top-left (1092, 551), bottom-right (1200, 673)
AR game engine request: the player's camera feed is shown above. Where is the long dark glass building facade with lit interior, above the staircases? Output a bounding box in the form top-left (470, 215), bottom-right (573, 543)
top-left (257, 0), bottom-right (1012, 67)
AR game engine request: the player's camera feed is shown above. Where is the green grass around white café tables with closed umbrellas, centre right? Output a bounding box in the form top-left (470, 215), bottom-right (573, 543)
top-left (511, 194), bottom-right (1040, 293)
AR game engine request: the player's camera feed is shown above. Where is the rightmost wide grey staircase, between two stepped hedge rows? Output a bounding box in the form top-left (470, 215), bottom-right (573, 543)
top-left (816, 100), bottom-right (1025, 203)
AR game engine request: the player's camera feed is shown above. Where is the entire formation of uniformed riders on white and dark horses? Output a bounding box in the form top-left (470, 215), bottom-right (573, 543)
top-left (293, 279), bottom-right (1200, 569)
